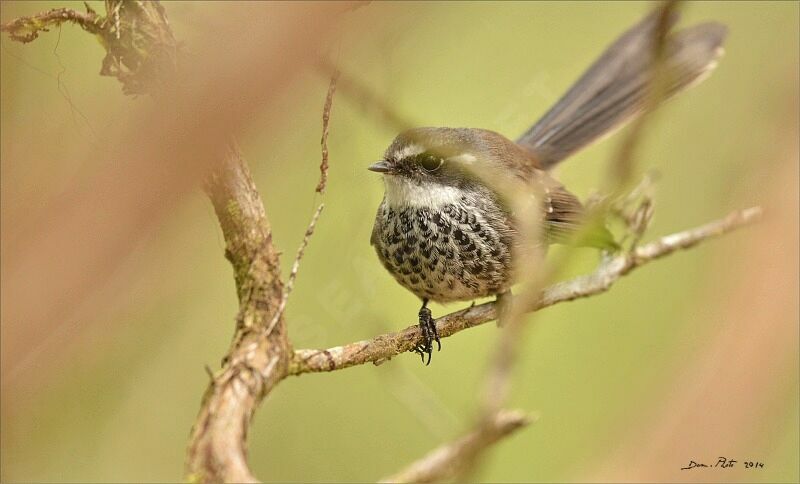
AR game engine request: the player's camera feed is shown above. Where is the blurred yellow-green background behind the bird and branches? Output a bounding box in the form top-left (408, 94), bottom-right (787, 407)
top-left (0, 2), bottom-right (800, 482)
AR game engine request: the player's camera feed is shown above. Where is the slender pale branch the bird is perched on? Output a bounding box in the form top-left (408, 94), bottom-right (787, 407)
top-left (289, 207), bottom-right (762, 375)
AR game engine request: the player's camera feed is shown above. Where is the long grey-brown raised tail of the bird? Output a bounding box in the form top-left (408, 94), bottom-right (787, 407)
top-left (517, 15), bottom-right (727, 168)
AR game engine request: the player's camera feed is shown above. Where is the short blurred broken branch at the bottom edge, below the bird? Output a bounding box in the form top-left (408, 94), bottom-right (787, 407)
top-left (381, 410), bottom-right (530, 482)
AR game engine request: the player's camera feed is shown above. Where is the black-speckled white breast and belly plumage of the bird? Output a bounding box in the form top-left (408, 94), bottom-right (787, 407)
top-left (372, 192), bottom-right (513, 302)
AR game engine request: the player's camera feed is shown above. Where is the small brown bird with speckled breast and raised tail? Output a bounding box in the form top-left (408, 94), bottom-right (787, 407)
top-left (368, 13), bottom-right (726, 364)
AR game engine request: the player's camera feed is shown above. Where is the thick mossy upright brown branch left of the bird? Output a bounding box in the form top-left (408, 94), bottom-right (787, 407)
top-left (186, 149), bottom-right (291, 482)
